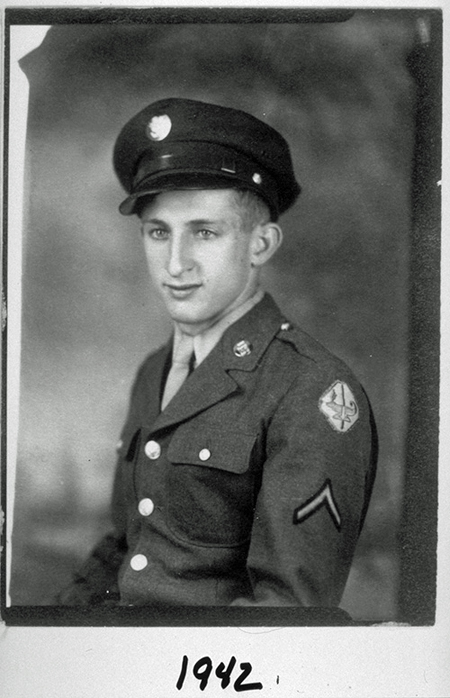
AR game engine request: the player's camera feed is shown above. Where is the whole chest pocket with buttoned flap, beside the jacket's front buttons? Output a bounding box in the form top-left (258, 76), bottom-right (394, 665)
top-left (166, 428), bottom-right (255, 546)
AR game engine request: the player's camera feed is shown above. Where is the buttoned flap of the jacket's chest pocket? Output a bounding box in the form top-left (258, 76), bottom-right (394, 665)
top-left (167, 428), bottom-right (255, 473)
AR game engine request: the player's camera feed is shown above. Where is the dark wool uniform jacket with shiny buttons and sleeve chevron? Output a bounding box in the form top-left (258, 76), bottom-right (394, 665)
top-left (61, 294), bottom-right (375, 607)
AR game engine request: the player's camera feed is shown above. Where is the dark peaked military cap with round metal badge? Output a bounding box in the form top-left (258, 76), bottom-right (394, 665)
top-left (114, 98), bottom-right (300, 220)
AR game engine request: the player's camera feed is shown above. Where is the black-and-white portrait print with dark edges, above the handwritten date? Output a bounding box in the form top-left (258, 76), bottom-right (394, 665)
top-left (2, 8), bottom-right (442, 626)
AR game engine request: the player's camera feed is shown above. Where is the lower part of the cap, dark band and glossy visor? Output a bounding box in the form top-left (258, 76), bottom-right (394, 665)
top-left (120, 141), bottom-right (279, 218)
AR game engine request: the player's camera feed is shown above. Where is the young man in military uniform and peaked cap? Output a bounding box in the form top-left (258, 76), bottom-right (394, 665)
top-left (61, 99), bottom-right (375, 607)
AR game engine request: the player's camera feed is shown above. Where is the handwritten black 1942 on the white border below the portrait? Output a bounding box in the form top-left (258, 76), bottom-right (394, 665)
top-left (176, 655), bottom-right (263, 693)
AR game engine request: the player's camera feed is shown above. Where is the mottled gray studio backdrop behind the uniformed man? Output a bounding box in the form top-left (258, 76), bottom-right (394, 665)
top-left (10, 11), bottom-right (418, 620)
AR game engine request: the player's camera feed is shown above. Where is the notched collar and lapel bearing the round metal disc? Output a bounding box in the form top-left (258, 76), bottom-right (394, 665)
top-left (149, 294), bottom-right (281, 432)
